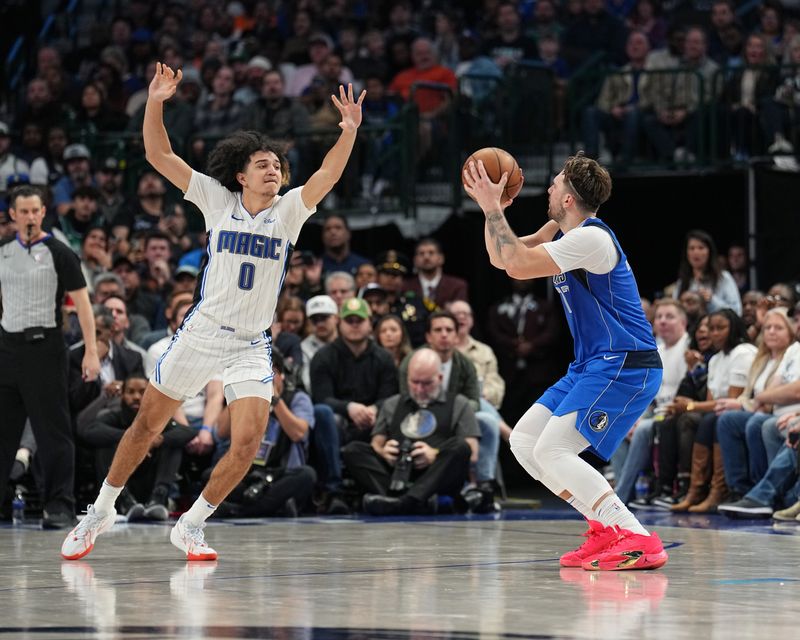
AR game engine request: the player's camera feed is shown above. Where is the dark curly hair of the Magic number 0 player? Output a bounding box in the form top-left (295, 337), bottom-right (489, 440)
top-left (208, 131), bottom-right (289, 191)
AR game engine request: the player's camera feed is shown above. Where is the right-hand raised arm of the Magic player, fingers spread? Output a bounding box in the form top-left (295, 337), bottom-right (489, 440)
top-left (301, 84), bottom-right (367, 209)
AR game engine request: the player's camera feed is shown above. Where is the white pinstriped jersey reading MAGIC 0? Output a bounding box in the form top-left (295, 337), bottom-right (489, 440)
top-left (184, 171), bottom-right (316, 333)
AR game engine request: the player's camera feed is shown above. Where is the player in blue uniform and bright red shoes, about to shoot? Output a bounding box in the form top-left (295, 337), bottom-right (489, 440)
top-left (464, 154), bottom-right (667, 571)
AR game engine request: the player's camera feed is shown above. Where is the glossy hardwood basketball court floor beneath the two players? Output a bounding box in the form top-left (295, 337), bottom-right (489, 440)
top-left (0, 509), bottom-right (800, 640)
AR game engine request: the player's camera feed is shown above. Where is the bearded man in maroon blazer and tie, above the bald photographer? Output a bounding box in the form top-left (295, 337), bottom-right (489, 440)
top-left (406, 238), bottom-right (469, 311)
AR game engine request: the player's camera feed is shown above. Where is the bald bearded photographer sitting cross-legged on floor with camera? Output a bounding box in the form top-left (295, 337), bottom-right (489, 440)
top-left (342, 348), bottom-right (480, 515)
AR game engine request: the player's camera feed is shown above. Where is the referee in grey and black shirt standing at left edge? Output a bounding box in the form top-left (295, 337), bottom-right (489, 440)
top-left (0, 185), bottom-right (100, 529)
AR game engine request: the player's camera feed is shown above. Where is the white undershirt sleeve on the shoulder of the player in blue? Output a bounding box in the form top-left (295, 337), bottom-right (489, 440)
top-left (541, 225), bottom-right (619, 274)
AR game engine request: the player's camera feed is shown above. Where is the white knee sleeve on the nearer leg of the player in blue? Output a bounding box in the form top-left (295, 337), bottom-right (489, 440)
top-left (533, 413), bottom-right (612, 508)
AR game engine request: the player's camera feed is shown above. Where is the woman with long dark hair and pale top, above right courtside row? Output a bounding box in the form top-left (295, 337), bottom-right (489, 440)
top-left (672, 229), bottom-right (742, 315)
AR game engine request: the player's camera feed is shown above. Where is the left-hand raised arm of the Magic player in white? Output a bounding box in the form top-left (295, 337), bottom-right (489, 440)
top-left (142, 62), bottom-right (192, 193)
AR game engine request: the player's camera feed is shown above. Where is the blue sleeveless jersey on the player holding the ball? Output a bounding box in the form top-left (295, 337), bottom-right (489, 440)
top-left (553, 218), bottom-right (656, 364)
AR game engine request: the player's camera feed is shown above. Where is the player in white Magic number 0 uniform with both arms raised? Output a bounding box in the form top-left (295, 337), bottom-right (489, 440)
top-left (61, 63), bottom-right (366, 560)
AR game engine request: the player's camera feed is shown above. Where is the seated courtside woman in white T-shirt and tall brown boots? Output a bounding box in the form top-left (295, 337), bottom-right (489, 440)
top-left (671, 309), bottom-right (758, 513)
